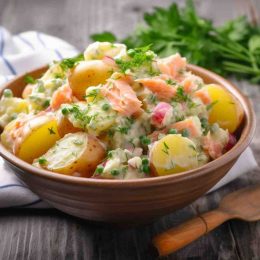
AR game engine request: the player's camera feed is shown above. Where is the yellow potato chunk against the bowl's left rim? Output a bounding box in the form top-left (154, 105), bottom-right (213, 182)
top-left (1, 114), bottom-right (60, 163)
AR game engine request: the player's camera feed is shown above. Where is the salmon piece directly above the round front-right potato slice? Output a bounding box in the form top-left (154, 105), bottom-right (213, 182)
top-left (170, 117), bottom-right (202, 138)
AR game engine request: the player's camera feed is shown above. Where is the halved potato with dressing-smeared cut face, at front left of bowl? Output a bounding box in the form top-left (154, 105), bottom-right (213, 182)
top-left (34, 132), bottom-right (105, 177)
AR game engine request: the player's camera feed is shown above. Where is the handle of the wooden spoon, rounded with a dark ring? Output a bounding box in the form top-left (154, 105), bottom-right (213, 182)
top-left (153, 209), bottom-right (230, 256)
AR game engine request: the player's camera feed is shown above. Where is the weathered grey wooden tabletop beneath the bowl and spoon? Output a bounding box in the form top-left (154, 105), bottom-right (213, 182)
top-left (0, 0), bottom-right (260, 260)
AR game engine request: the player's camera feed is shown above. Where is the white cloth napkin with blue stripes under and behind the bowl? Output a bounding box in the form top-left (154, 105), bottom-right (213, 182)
top-left (0, 27), bottom-right (257, 208)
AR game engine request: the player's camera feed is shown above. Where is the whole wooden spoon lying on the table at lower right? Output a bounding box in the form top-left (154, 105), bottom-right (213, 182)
top-left (153, 184), bottom-right (260, 256)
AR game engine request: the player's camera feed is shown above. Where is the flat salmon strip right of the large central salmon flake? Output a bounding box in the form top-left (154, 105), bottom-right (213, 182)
top-left (136, 77), bottom-right (176, 101)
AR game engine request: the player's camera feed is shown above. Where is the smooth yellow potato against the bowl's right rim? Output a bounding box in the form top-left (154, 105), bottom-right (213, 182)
top-left (205, 84), bottom-right (244, 133)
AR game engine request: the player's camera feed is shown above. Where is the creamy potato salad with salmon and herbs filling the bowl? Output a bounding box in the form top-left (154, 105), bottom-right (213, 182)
top-left (0, 42), bottom-right (243, 179)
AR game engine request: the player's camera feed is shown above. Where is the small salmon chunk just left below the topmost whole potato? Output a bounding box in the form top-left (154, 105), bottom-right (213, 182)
top-left (50, 85), bottom-right (72, 110)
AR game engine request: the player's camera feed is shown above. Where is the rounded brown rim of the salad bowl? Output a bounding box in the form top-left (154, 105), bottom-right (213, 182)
top-left (0, 64), bottom-right (256, 189)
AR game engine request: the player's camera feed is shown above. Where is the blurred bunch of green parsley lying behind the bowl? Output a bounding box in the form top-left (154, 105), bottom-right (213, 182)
top-left (91, 0), bottom-right (260, 83)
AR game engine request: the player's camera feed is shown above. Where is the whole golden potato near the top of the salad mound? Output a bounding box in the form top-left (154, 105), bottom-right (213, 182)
top-left (68, 60), bottom-right (112, 100)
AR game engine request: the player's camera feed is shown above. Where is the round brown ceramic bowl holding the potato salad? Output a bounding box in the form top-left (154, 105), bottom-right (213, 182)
top-left (0, 65), bottom-right (255, 224)
